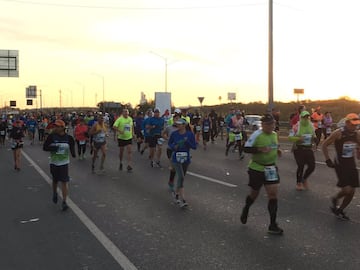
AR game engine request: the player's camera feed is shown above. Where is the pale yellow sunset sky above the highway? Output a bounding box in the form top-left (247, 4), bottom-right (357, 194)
top-left (0, 0), bottom-right (360, 108)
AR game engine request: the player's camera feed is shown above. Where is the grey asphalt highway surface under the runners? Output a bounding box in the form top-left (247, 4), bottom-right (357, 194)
top-left (0, 133), bottom-right (360, 270)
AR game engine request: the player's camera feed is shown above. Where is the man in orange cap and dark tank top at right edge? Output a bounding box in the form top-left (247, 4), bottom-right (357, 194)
top-left (322, 113), bottom-right (360, 220)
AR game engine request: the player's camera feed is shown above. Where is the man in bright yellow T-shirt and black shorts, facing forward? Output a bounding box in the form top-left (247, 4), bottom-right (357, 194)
top-left (113, 109), bottom-right (134, 172)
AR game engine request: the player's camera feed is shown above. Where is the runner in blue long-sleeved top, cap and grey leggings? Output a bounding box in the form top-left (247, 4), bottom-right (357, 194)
top-left (168, 119), bottom-right (196, 208)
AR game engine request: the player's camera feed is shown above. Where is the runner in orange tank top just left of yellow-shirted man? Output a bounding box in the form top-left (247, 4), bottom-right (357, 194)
top-left (89, 115), bottom-right (107, 173)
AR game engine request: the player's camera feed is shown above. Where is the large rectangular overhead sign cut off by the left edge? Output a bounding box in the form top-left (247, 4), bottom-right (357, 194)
top-left (0, 50), bottom-right (19, 77)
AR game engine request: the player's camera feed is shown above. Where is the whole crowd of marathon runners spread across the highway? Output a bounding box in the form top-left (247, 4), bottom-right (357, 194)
top-left (0, 105), bottom-right (360, 234)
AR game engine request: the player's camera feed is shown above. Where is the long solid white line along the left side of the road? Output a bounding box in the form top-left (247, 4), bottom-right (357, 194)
top-left (22, 151), bottom-right (137, 270)
